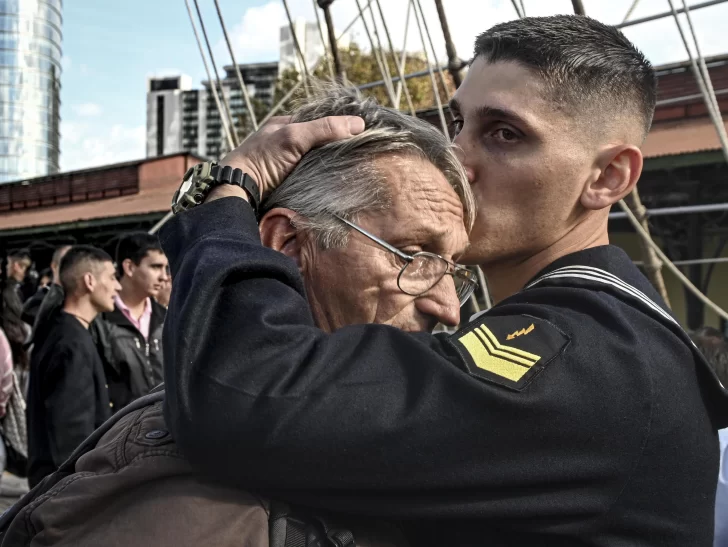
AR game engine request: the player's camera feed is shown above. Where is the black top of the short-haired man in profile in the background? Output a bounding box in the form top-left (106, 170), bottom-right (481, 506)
top-left (27, 311), bottom-right (111, 487)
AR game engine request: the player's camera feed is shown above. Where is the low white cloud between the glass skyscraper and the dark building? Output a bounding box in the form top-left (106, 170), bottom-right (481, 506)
top-left (61, 121), bottom-right (146, 171)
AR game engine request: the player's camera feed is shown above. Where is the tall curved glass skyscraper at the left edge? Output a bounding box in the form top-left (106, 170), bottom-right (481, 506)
top-left (0, 0), bottom-right (63, 184)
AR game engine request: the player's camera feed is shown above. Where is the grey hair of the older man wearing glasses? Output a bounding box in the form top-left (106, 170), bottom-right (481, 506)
top-left (261, 85), bottom-right (475, 249)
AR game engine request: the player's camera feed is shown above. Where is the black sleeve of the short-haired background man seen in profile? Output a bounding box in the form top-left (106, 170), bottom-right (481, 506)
top-left (45, 344), bottom-right (97, 466)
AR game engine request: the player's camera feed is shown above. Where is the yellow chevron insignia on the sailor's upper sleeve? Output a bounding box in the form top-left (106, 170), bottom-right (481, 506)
top-left (458, 324), bottom-right (541, 382)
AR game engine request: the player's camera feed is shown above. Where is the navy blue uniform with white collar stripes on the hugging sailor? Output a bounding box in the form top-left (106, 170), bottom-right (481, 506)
top-left (161, 198), bottom-right (728, 546)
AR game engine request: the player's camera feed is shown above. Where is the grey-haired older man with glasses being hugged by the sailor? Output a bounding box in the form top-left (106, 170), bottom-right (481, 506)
top-left (2, 88), bottom-right (475, 547)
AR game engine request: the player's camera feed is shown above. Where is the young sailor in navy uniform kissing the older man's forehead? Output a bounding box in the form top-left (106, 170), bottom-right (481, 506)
top-left (162, 16), bottom-right (728, 546)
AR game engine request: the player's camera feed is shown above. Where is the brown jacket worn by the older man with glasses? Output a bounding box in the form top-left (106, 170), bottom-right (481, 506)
top-left (2, 402), bottom-right (406, 547)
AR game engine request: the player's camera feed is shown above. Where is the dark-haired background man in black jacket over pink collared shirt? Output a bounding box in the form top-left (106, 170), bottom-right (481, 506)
top-left (92, 232), bottom-right (169, 409)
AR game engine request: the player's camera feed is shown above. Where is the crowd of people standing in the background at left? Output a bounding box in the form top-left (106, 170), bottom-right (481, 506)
top-left (0, 232), bottom-right (171, 487)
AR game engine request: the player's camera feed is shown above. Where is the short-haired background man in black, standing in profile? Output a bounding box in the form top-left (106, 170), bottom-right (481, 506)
top-left (27, 245), bottom-right (121, 487)
